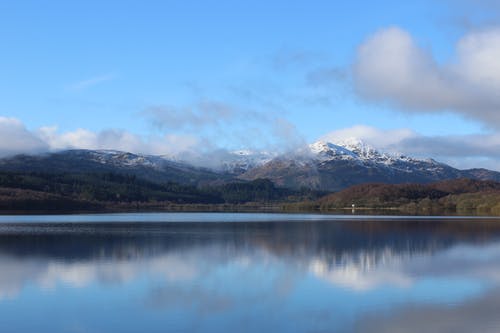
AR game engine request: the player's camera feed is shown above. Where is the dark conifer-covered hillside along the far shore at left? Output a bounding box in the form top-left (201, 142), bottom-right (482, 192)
top-left (0, 172), bottom-right (324, 211)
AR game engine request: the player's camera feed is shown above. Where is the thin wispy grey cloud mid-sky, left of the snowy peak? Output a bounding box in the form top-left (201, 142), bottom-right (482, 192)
top-left (141, 100), bottom-right (305, 152)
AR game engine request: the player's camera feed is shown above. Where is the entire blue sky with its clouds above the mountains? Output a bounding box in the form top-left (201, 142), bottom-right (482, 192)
top-left (0, 0), bottom-right (500, 169)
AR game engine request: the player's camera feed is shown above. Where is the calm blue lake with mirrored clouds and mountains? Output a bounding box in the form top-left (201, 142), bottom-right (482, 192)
top-left (0, 214), bottom-right (500, 333)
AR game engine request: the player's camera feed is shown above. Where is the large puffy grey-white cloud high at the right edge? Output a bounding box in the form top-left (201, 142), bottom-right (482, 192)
top-left (353, 27), bottom-right (500, 128)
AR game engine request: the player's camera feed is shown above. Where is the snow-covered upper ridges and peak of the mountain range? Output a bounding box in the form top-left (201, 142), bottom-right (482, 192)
top-left (72, 138), bottom-right (441, 174)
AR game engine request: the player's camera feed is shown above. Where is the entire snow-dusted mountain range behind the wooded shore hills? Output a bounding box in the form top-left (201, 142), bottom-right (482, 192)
top-left (0, 139), bottom-right (500, 191)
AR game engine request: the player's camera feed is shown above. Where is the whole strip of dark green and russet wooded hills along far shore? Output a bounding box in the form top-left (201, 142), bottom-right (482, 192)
top-left (0, 172), bottom-right (500, 215)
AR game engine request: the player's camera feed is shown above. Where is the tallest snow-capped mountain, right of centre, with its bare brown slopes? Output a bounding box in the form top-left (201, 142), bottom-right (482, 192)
top-left (240, 140), bottom-right (500, 191)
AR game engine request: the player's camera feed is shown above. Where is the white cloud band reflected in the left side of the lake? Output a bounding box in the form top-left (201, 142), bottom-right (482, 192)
top-left (0, 254), bottom-right (201, 300)
